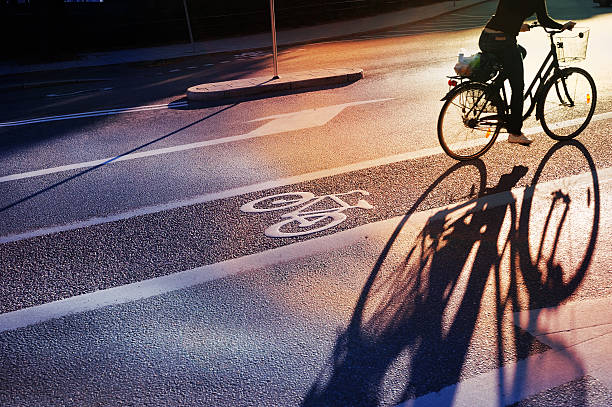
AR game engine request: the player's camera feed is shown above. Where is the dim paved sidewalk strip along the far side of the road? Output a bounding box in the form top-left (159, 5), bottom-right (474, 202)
top-left (0, 0), bottom-right (489, 76)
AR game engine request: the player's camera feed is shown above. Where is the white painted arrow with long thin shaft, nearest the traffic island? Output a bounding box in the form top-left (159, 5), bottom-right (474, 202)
top-left (0, 99), bottom-right (391, 183)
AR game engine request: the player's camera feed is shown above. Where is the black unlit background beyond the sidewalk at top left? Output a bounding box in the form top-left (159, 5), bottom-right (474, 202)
top-left (0, 0), bottom-right (454, 62)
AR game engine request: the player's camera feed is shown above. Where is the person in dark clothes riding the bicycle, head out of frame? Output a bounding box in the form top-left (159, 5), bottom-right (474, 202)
top-left (478, 0), bottom-right (576, 145)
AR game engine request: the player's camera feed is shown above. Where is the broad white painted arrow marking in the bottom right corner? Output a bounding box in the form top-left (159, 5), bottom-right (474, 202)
top-left (397, 298), bottom-right (612, 407)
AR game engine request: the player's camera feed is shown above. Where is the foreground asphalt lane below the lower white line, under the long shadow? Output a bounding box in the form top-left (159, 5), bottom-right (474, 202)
top-left (0, 143), bottom-right (612, 406)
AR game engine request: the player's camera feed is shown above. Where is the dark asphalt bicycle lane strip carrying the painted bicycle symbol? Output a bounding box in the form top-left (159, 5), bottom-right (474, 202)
top-left (0, 110), bottom-right (612, 312)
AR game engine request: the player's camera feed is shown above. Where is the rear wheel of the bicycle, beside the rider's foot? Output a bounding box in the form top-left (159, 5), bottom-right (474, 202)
top-left (438, 83), bottom-right (502, 161)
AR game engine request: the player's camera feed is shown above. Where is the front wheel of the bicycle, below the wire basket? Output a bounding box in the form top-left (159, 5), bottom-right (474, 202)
top-left (537, 67), bottom-right (597, 140)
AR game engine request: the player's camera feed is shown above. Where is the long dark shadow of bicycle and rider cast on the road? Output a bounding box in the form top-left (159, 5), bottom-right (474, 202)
top-left (302, 142), bottom-right (599, 406)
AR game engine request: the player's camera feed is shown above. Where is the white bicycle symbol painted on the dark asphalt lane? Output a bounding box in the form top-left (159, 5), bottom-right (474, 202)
top-left (240, 190), bottom-right (374, 237)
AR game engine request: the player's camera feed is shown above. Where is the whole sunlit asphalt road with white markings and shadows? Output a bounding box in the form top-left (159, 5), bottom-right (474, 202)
top-left (0, 0), bottom-right (612, 406)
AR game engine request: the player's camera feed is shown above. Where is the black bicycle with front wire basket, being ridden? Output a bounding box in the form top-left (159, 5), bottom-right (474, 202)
top-left (438, 23), bottom-right (597, 161)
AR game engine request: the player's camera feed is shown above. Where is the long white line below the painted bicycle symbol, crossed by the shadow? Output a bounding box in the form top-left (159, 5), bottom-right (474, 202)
top-left (0, 168), bottom-right (612, 334)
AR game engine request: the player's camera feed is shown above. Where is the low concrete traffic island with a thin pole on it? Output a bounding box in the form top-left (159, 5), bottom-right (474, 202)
top-left (187, 68), bottom-right (363, 101)
